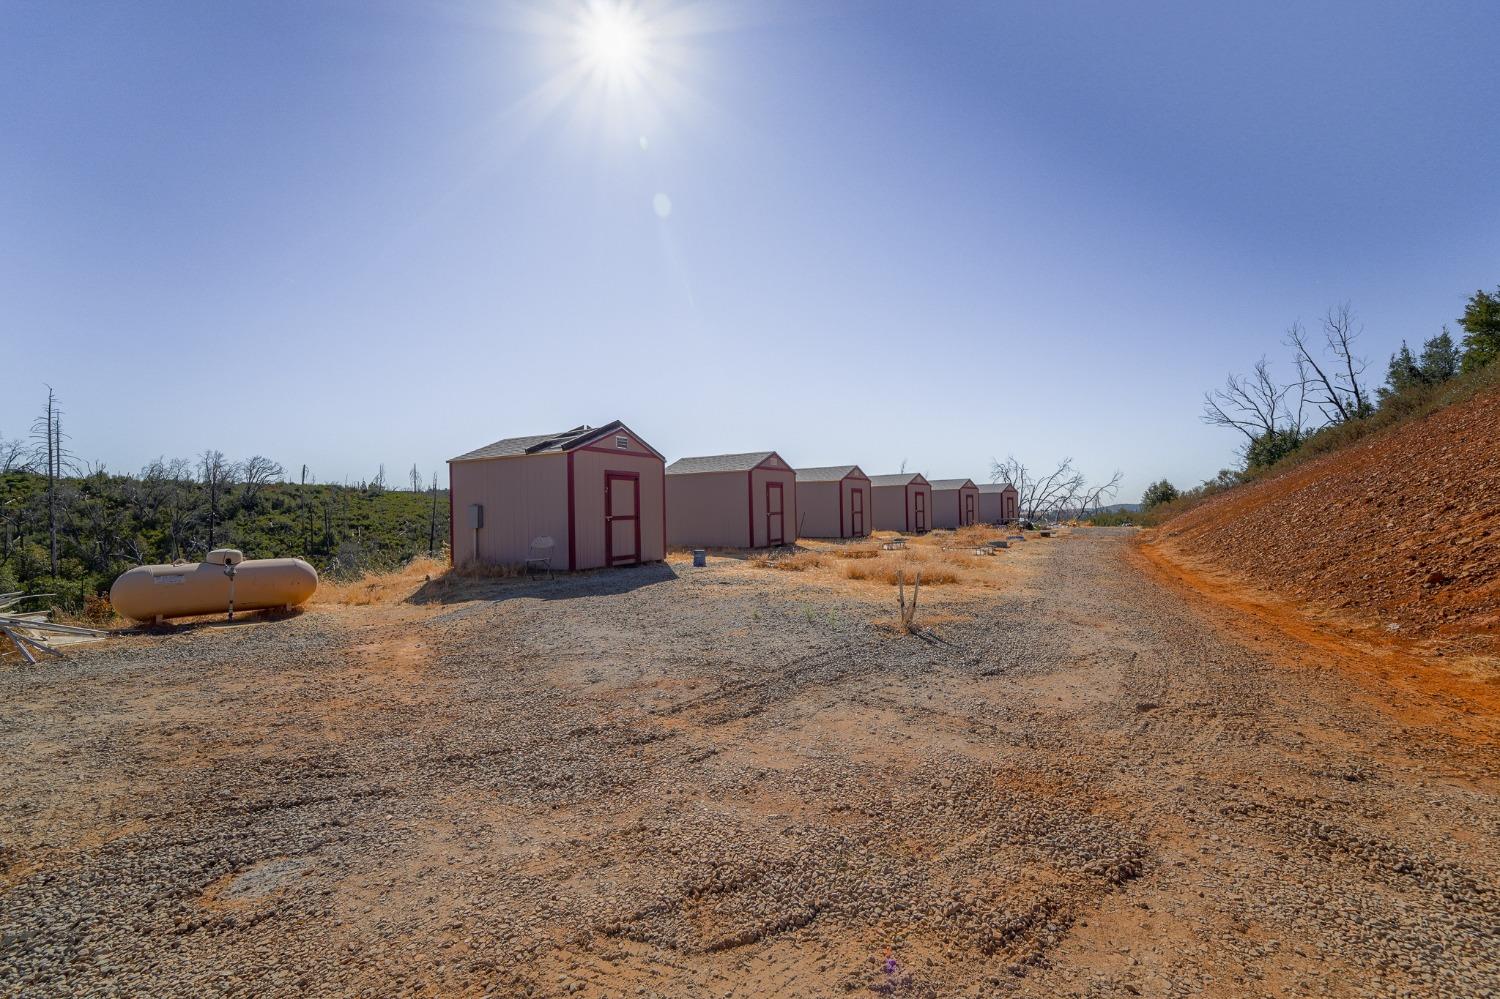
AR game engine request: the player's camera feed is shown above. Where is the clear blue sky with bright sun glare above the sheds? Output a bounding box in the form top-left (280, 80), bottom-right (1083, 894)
top-left (0, 0), bottom-right (1500, 500)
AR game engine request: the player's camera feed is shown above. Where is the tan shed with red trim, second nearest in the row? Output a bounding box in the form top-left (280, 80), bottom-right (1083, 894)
top-left (666, 452), bottom-right (797, 548)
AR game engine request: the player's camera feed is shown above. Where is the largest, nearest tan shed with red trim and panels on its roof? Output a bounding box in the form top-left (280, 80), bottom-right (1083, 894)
top-left (449, 420), bottom-right (666, 570)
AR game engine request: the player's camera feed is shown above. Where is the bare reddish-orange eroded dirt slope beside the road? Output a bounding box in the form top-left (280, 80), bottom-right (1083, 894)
top-left (1157, 392), bottom-right (1500, 653)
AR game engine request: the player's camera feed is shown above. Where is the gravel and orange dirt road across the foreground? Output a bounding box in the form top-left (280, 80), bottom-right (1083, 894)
top-left (0, 531), bottom-right (1500, 999)
